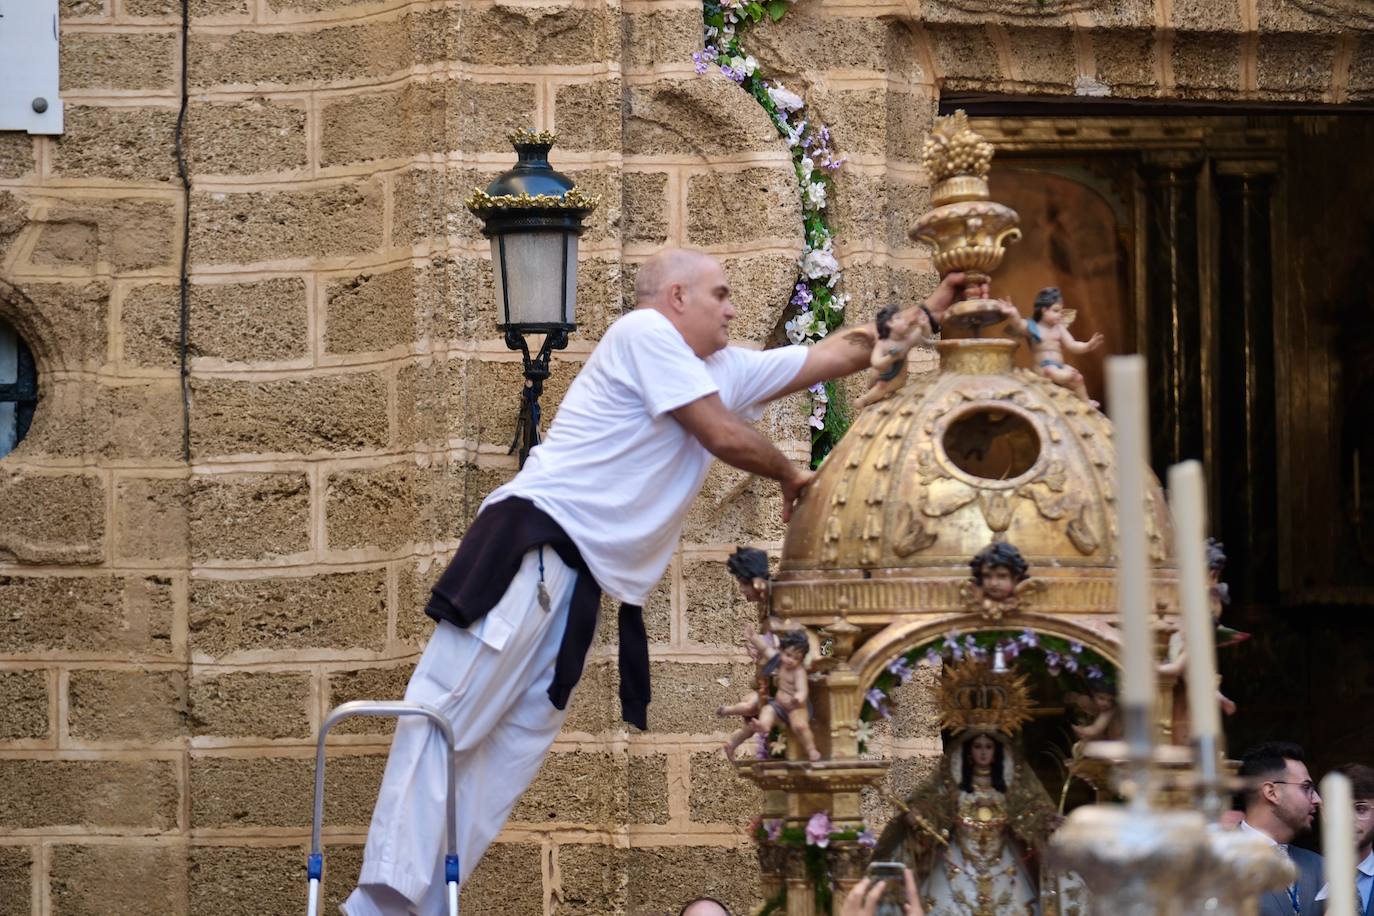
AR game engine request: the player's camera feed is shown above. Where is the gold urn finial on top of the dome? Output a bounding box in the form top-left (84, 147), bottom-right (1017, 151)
top-left (911, 110), bottom-right (1021, 330)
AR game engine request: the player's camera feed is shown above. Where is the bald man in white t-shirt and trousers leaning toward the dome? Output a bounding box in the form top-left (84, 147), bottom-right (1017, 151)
top-left (344, 249), bottom-right (963, 916)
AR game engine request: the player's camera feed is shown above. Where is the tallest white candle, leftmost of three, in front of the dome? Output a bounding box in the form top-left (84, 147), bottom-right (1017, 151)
top-left (1106, 356), bottom-right (1156, 722)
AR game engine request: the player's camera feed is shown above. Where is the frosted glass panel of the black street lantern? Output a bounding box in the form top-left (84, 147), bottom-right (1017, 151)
top-left (492, 232), bottom-right (577, 325)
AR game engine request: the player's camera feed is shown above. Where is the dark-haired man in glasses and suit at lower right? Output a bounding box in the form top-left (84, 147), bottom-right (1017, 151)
top-left (1239, 742), bottom-right (1323, 916)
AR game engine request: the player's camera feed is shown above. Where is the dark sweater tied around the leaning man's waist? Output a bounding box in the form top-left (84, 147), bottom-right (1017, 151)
top-left (425, 496), bottom-right (649, 729)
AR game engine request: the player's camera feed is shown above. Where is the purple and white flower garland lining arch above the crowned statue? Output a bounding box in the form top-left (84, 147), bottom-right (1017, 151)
top-left (859, 630), bottom-right (1114, 747)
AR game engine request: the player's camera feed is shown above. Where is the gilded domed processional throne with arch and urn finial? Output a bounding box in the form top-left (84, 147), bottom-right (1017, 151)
top-left (736, 113), bottom-right (1178, 916)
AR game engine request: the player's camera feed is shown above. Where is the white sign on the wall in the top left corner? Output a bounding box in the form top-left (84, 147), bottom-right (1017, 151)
top-left (0, 0), bottom-right (62, 133)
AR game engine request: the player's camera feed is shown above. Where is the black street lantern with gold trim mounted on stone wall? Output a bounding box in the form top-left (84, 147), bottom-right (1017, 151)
top-left (467, 130), bottom-right (599, 466)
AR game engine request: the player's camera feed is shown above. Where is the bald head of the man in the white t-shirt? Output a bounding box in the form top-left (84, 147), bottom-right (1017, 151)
top-left (635, 249), bottom-right (735, 360)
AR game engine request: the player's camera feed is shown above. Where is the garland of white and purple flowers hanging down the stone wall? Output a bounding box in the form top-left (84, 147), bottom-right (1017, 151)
top-left (692, 0), bottom-right (849, 467)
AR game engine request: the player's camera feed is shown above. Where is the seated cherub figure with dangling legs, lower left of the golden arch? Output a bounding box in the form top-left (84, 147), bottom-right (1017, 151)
top-left (716, 630), bottom-right (820, 761)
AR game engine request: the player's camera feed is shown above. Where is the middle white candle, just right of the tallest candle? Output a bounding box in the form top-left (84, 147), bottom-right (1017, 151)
top-left (1169, 461), bottom-right (1221, 739)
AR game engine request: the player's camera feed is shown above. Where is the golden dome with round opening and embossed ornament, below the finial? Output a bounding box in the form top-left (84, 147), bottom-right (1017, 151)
top-left (775, 338), bottom-right (1176, 631)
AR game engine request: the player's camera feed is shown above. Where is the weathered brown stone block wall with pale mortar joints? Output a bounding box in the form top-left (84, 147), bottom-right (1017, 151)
top-left (0, 0), bottom-right (1374, 916)
